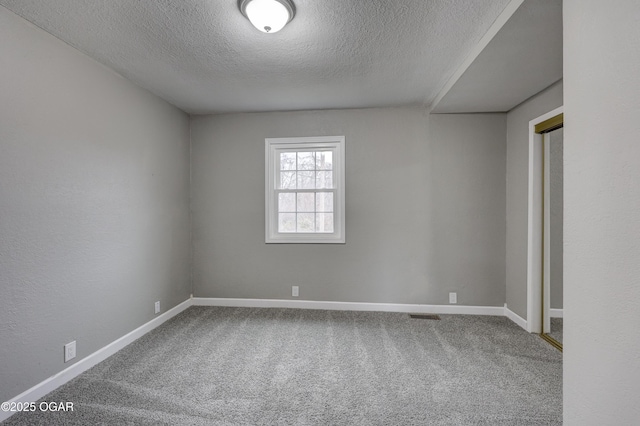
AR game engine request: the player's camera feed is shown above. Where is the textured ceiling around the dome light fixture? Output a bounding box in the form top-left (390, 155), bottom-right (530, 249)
top-left (0, 0), bottom-right (509, 113)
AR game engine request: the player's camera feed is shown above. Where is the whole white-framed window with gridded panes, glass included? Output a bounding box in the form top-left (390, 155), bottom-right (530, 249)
top-left (265, 136), bottom-right (345, 243)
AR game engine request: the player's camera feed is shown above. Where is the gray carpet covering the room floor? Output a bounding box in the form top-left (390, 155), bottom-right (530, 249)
top-left (5, 307), bottom-right (562, 425)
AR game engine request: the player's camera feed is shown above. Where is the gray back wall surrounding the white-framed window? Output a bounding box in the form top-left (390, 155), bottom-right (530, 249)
top-left (191, 108), bottom-right (506, 306)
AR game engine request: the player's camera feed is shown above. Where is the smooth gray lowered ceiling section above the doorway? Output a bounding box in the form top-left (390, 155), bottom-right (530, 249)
top-left (432, 0), bottom-right (562, 113)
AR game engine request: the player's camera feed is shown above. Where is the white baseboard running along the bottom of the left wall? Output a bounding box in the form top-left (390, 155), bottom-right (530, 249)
top-left (0, 299), bottom-right (192, 422)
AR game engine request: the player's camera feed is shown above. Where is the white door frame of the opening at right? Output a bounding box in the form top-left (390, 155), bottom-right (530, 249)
top-left (527, 107), bottom-right (563, 333)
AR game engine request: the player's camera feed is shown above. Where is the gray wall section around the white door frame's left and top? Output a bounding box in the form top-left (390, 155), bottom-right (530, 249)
top-left (506, 83), bottom-right (562, 319)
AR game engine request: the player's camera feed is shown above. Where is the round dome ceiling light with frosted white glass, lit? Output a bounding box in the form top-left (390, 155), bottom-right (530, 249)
top-left (238, 0), bottom-right (296, 33)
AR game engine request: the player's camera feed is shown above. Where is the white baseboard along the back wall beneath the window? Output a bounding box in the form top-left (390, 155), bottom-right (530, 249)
top-left (193, 297), bottom-right (504, 316)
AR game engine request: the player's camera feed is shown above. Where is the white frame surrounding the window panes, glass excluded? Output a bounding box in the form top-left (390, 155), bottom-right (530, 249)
top-left (265, 136), bottom-right (345, 244)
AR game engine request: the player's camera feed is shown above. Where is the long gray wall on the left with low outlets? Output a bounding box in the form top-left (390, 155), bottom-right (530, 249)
top-left (0, 7), bottom-right (190, 401)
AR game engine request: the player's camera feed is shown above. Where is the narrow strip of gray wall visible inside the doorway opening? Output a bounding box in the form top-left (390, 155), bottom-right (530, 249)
top-left (549, 129), bottom-right (564, 309)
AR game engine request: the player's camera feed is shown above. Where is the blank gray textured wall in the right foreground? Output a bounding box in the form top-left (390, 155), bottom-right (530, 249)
top-left (564, 0), bottom-right (640, 426)
